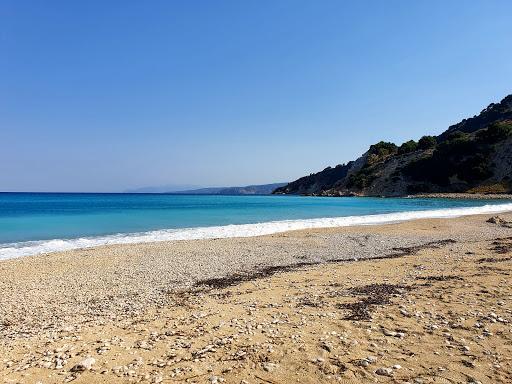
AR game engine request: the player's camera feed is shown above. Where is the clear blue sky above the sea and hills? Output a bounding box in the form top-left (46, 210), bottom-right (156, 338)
top-left (0, 0), bottom-right (512, 191)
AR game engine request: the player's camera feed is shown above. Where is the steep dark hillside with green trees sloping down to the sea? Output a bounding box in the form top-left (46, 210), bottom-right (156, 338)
top-left (274, 95), bottom-right (512, 196)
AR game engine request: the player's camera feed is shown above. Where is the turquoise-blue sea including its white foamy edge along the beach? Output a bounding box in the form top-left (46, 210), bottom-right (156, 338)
top-left (0, 193), bottom-right (512, 259)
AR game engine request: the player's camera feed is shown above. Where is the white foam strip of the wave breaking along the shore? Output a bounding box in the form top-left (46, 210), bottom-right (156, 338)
top-left (0, 203), bottom-right (512, 260)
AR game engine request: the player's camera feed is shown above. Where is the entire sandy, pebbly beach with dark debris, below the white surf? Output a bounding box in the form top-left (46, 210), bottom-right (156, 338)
top-left (0, 214), bottom-right (512, 384)
